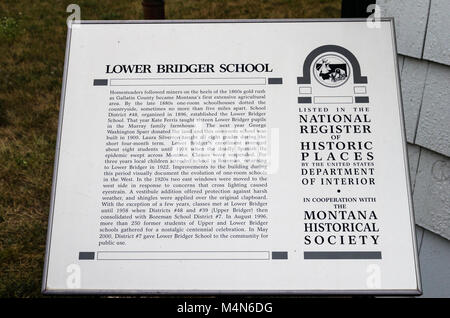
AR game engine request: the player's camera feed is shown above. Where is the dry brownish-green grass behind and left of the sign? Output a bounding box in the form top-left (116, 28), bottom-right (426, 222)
top-left (0, 0), bottom-right (340, 297)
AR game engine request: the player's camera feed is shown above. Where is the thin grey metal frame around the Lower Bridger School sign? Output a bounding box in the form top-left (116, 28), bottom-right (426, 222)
top-left (42, 18), bottom-right (422, 296)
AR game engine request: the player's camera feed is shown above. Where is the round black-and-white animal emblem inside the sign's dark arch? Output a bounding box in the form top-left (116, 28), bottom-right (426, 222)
top-left (312, 53), bottom-right (350, 87)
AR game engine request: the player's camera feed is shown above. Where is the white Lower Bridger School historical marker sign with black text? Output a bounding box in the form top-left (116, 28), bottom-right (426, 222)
top-left (43, 20), bottom-right (420, 294)
